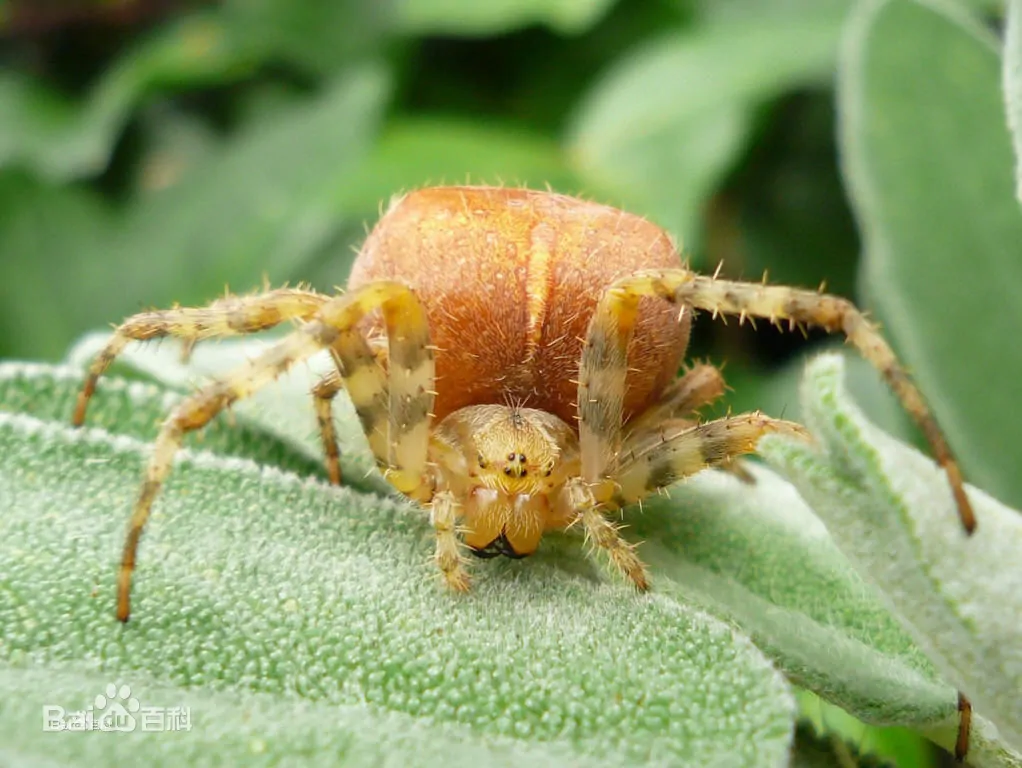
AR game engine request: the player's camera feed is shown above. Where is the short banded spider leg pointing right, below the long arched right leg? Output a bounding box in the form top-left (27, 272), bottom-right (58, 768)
top-left (610, 413), bottom-right (808, 506)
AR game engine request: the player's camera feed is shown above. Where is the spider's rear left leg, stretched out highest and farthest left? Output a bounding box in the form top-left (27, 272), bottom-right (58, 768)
top-left (72, 288), bottom-right (329, 426)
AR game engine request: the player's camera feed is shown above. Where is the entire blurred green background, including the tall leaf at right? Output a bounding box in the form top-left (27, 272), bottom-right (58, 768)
top-left (0, 0), bottom-right (1022, 764)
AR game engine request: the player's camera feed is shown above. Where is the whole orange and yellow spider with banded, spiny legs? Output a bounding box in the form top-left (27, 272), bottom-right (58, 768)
top-left (73, 186), bottom-right (975, 622)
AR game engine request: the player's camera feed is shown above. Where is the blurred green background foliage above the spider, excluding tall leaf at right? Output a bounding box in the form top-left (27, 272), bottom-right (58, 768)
top-left (0, 0), bottom-right (857, 366)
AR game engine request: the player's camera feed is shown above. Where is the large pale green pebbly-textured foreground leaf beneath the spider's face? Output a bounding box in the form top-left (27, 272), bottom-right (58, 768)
top-left (0, 364), bottom-right (794, 766)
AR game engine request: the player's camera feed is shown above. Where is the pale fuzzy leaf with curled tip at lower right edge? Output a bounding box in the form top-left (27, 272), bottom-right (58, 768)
top-left (760, 356), bottom-right (1022, 764)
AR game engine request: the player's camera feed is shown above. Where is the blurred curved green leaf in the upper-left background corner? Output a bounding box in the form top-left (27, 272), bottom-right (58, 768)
top-left (0, 13), bottom-right (265, 181)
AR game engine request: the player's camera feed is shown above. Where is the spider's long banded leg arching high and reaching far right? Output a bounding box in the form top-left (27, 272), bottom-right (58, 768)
top-left (578, 269), bottom-right (976, 533)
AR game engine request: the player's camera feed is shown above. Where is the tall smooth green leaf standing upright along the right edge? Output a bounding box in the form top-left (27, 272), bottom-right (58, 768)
top-left (839, 0), bottom-right (1022, 513)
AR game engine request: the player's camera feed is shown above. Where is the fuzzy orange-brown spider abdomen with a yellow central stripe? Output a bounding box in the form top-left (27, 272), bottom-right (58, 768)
top-left (349, 186), bottom-right (691, 424)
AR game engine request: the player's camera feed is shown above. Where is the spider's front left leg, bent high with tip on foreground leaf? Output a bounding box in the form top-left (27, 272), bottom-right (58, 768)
top-left (118, 281), bottom-right (433, 622)
